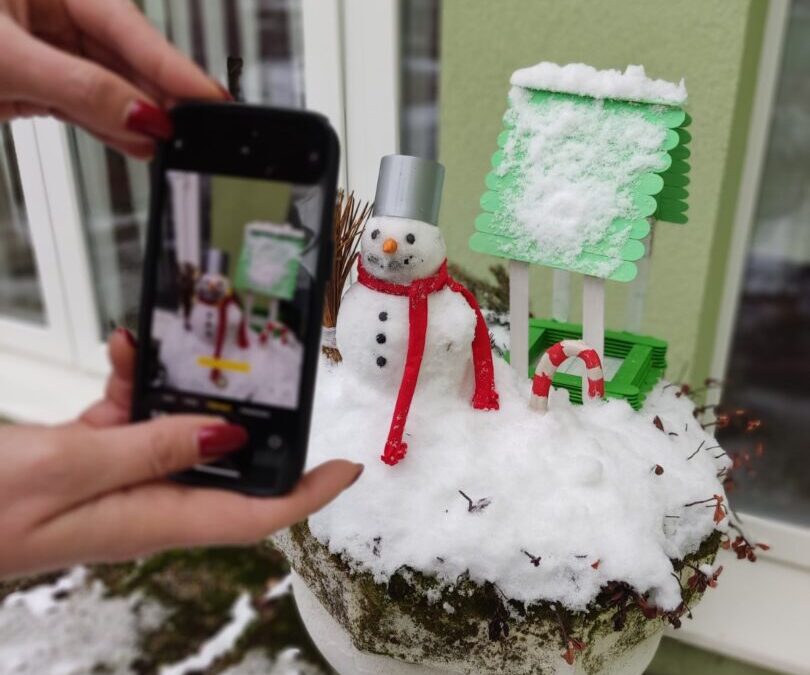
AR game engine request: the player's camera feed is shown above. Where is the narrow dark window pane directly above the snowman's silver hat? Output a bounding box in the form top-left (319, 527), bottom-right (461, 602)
top-left (400, 0), bottom-right (441, 159)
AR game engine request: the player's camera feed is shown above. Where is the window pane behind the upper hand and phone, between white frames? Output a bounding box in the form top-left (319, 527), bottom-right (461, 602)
top-left (70, 0), bottom-right (304, 338)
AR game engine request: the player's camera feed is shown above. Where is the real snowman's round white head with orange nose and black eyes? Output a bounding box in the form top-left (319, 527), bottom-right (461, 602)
top-left (360, 216), bottom-right (447, 284)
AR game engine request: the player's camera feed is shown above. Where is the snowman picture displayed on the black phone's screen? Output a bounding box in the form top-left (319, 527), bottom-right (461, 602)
top-left (152, 172), bottom-right (317, 409)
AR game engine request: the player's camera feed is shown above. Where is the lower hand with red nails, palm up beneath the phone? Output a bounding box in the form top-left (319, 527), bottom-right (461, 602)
top-left (0, 330), bottom-right (363, 577)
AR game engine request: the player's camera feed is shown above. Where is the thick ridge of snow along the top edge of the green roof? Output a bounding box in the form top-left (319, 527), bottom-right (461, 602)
top-left (510, 61), bottom-right (686, 105)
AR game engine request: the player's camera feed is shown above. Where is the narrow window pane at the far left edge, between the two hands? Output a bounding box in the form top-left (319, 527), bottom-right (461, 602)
top-left (0, 124), bottom-right (45, 324)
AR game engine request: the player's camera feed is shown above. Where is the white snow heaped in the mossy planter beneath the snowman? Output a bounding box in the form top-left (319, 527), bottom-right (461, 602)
top-left (308, 359), bottom-right (730, 610)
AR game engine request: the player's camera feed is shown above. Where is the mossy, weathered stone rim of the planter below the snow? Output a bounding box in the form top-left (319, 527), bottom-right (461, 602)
top-left (276, 523), bottom-right (720, 675)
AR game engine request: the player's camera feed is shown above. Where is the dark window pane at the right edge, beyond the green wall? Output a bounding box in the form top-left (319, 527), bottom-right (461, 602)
top-left (725, 0), bottom-right (810, 525)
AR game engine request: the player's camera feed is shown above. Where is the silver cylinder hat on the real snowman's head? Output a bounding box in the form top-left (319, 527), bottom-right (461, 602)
top-left (373, 155), bottom-right (444, 225)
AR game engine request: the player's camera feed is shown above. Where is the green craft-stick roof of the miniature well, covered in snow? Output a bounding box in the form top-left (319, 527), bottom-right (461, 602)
top-left (470, 63), bottom-right (691, 281)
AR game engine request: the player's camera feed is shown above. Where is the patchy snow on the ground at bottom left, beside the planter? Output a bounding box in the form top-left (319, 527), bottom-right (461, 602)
top-left (0, 567), bottom-right (321, 675)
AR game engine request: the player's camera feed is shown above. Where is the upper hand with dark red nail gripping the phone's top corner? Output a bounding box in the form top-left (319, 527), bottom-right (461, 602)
top-left (0, 0), bottom-right (228, 158)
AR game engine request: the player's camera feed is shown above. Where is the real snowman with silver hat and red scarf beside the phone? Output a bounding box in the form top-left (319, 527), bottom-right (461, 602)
top-left (335, 155), bottom-right (498, 465)
